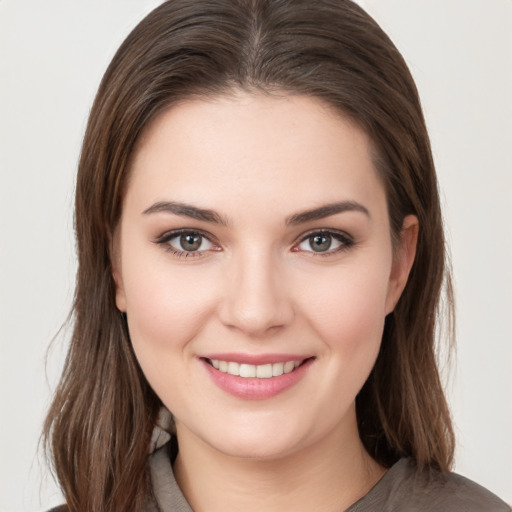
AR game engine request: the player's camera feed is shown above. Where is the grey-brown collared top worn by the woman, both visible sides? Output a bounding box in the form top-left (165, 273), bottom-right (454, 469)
top-left (145, 445), bottom-right (512, 512)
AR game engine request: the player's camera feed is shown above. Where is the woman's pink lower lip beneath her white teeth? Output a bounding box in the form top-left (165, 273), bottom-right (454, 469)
top-left (201, 359), bottom-right (313, 400)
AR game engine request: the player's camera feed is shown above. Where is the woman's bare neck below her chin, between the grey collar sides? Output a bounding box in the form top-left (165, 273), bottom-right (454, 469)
top-left (174, 412), bottom-right (385, 512)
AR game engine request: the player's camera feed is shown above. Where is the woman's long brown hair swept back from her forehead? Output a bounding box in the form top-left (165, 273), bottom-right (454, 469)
top-left (45, 0), bottom-right (454, 512)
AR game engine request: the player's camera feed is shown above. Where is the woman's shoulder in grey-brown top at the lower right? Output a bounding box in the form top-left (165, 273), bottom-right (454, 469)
top-left (347, 459), bottom-right (512, 512)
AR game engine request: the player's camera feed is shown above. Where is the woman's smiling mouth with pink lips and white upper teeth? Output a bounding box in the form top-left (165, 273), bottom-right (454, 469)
top-left (201, 355), bottom-right (314, 400)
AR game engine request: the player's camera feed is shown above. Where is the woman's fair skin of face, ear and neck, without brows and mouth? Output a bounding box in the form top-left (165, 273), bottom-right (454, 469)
top-left (114, 92), bottom-right (418, 512)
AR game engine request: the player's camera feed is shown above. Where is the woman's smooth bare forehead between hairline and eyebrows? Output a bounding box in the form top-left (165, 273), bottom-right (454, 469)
top-left (126, 93), bottom-right (384, 218)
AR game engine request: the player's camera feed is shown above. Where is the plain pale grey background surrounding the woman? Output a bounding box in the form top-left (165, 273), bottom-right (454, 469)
top-left (0, 0), bottom-right (512, 512)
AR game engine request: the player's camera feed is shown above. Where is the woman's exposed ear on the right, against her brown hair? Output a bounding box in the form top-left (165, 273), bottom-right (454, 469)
top-left (386, 215), bottom-right (419, 315)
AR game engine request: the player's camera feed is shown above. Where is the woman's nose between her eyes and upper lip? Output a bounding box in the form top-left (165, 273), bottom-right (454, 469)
top-left (219, 252), bottom-right (294, 337)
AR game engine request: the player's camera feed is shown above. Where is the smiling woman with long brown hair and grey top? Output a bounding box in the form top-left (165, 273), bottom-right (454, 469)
top-left (46, 0), bottom-right (510, 511)
